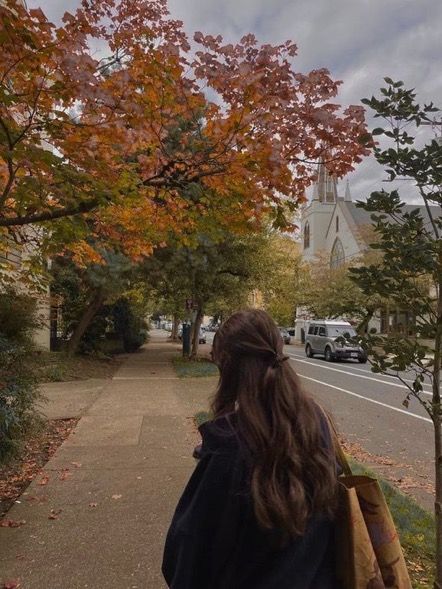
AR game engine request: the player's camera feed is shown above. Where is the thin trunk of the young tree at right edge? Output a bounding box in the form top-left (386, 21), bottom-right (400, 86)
top-left (432, 281), bottom-right (442, 589)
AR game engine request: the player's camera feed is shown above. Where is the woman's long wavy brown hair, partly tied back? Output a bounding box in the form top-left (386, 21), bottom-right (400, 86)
top-left (212, 309), bottom-right (337, 537)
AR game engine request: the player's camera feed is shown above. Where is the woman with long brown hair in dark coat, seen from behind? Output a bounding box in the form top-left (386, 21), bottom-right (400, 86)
top-left (163, 309), bottom-right (337, 589)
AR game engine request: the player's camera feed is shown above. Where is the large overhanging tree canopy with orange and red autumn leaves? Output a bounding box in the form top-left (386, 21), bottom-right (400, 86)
top-left (0, 0), bottom-right (367, 255)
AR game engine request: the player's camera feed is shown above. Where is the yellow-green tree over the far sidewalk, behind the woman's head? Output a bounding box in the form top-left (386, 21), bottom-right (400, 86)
top-left (144, 230), bottom-right (293, 357)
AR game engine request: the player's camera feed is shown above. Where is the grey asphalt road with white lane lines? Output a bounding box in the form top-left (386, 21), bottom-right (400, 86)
top-left (207, 332), bottom-right (434, 509)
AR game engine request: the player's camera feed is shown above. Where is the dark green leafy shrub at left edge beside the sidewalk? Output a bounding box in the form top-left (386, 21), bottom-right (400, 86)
top-left (0, 288), bottom-right (40, 461)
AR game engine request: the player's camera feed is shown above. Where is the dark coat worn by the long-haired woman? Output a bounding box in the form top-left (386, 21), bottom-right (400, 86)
top-left (162, 416), bottom-right (336, 589)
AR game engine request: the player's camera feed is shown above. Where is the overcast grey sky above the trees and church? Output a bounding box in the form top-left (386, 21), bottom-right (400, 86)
top-left (27, 0), bottom-right (442, 200)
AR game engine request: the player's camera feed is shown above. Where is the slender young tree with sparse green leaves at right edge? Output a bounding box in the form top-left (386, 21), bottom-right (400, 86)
top-left (351, 78), bottom-right (442, 589)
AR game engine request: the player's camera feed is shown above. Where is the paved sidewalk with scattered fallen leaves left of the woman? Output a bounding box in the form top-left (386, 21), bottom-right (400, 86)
top-left (0, 335), bottom-right (215, 589)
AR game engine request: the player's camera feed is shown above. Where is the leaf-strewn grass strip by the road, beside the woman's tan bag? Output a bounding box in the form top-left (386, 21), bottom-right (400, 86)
top-left (194, 411), bottom-right (436, 589)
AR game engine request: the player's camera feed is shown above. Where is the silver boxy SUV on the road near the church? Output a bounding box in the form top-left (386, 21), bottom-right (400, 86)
top-left (305, 319), bottom-right (367, 364)
